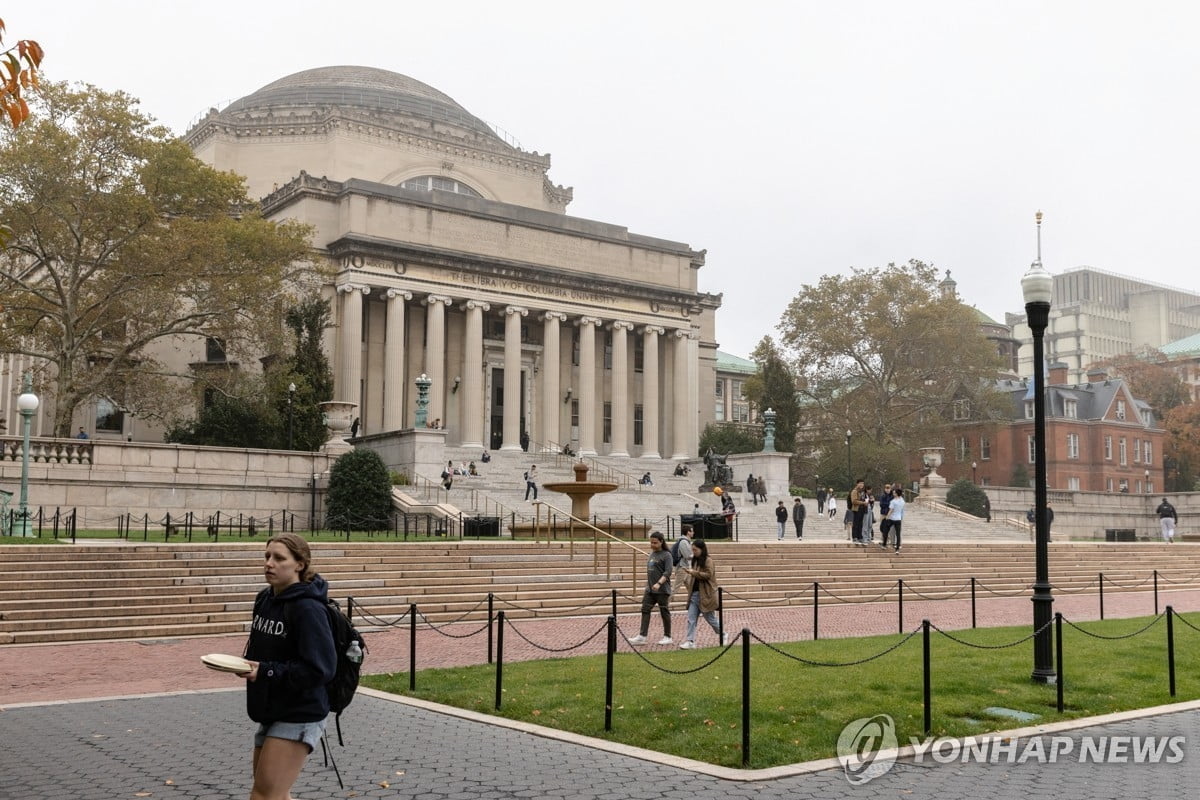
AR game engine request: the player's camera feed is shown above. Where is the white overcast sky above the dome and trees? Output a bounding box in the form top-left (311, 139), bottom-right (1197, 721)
top-left (9, 0), bottom-right (1200, 355)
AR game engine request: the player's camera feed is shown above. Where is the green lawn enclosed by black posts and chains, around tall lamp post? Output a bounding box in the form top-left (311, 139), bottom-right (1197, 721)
top-left (362, 613), bottom-right (1200, 768)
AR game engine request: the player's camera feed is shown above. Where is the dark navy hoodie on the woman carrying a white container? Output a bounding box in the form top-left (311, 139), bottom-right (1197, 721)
top-left (246, 575), bottom-right (337, 724)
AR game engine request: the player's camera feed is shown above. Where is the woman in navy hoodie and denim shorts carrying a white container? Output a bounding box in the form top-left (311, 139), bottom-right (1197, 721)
top-left (244, 534), bottom-right (337, 800)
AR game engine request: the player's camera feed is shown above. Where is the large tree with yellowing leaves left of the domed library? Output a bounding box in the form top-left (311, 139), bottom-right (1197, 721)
top-left (0, 84), bottom-right (310, 435)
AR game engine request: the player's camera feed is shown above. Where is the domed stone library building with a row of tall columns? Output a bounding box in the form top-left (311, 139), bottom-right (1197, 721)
top-left (186, 66), bottom-right (720, 458)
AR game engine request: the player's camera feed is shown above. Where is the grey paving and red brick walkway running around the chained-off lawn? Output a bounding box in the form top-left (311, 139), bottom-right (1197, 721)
top-left (0, 591), bottom-right (1200, 800)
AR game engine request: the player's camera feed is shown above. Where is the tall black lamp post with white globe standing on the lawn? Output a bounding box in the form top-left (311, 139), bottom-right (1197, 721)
top-left (1021, 245), bottom-right (1057, 684)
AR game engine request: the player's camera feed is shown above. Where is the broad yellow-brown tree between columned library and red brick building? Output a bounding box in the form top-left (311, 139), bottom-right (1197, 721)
top-left (779, 260), bottom-right (1002, 471)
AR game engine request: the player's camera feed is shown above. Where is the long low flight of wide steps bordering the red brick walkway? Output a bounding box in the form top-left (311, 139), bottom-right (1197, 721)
top-left (0, 537), bottom-right (1200, 644)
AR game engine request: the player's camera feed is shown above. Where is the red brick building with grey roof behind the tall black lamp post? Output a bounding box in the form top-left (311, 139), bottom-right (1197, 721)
top-left (914, 363), bottom-right (1165, 493)
